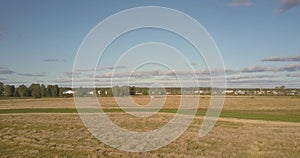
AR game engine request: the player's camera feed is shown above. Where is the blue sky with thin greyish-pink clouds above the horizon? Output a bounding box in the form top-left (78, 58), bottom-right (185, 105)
top-left (0, 0), bottom-right (300, 88)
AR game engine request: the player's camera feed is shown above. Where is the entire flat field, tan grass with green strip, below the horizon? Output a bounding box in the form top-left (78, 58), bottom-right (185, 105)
top-left (0, 96), bottom-right (300, 157)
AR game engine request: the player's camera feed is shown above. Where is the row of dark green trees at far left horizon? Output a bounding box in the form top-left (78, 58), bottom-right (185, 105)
top-left (0, 82), bottom-right (70, 98)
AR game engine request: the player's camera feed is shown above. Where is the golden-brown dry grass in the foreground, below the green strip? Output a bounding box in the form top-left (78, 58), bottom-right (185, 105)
top-left (0, 113), bottom-right (300, 157)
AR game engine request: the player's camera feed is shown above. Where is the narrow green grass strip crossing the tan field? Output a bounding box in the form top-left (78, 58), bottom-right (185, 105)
top-left (0, 108), bottom-right (300, 122)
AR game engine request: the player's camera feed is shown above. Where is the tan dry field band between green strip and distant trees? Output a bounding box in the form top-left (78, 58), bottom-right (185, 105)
top-left (0, 96), bottom-right (300, 111)
